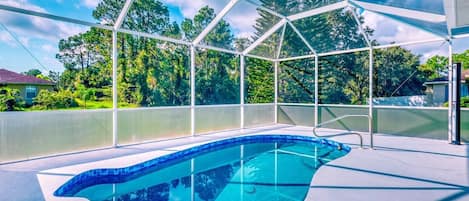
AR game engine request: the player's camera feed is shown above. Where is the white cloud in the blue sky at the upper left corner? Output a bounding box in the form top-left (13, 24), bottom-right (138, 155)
top-left (0, 0), bottom-right (89, 71)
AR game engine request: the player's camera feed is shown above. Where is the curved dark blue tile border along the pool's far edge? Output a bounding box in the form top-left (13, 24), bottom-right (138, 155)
top-left (53, 134), bottom-right (351, 198)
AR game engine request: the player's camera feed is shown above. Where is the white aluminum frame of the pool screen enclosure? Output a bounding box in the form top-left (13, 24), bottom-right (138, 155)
top-left (0, 0), bottom-right (462, 151)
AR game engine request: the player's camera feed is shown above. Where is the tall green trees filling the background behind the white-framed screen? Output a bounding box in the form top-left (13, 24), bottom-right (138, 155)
top-left (42, 0), bottom-right (448, 108)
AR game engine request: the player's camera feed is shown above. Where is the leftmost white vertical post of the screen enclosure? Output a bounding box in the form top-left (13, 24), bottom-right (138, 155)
top-left (112, 30), bottom-right (118, 147)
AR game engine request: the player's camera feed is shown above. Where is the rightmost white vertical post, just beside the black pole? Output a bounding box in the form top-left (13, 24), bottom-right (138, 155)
top-left (448, 40), bottom-right (454, 143)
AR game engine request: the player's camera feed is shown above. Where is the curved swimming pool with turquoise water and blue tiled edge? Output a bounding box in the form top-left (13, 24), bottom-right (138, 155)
top-left (54, 135), bottom-right (350, 201)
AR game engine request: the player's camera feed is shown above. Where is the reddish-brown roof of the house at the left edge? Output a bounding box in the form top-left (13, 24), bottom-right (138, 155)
top-left (0, 68), bottom-right (54, 85)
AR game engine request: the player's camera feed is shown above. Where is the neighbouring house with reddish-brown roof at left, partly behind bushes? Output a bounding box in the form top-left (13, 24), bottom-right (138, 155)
top-left (0, 69), bottom-right (55, 104)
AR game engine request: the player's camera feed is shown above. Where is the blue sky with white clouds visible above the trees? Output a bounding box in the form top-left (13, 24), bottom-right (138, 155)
top-left (0, 0), bottom-right (469, 73)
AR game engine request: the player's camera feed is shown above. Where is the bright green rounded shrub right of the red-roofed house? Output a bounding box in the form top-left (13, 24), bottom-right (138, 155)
top-left (33, 90), bottom-right (78, 110)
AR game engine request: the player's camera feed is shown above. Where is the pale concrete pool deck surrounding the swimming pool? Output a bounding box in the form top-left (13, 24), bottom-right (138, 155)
top-left (0, 125), bottom-right (469, 201)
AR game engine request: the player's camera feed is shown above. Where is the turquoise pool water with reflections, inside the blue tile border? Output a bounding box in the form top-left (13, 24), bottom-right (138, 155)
top-left (75, 143), bottom-right (343, 201)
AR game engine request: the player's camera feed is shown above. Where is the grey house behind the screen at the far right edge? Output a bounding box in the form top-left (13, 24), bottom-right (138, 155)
top-left (423, 70), bottom-right (469, 106)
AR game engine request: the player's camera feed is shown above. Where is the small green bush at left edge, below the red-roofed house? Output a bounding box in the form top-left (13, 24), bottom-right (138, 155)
top-left (0, 87), bottom-right (25, 112)
